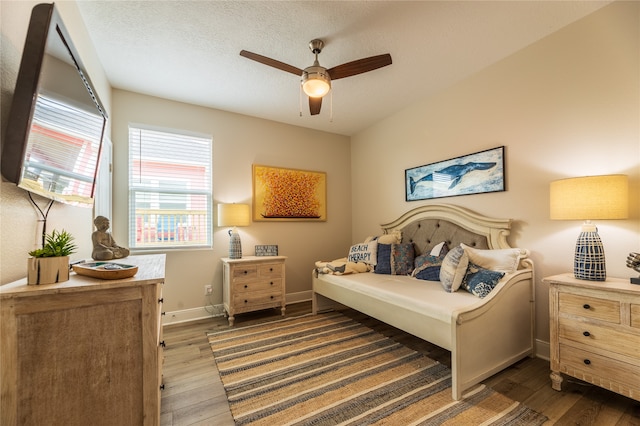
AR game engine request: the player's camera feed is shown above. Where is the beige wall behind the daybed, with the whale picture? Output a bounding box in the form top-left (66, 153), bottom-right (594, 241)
top-left (351, 2), bottom-right (640, 341)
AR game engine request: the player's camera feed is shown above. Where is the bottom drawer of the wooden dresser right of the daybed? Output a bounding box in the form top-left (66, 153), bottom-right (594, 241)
top-left (560, 343), bottom-right (640, 392)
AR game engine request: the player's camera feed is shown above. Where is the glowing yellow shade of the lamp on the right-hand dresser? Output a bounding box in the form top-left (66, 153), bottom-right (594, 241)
top-left (550, 175), bottom-right (629, 220)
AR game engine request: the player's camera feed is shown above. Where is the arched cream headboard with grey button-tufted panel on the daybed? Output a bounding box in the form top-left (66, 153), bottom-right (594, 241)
top-left (381, 204), bottom-right (511, 255)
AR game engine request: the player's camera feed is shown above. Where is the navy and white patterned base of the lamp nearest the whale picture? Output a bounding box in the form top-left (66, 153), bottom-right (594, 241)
top-left (573, 225), bottom-right (607, 281)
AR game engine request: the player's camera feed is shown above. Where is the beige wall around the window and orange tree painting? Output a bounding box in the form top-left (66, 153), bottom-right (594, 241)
top-left (112, 90), bottom-right (351, 320)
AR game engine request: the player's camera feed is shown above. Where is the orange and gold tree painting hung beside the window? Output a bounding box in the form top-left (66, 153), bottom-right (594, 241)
top-left (253, 164), bottom-right (327, 222)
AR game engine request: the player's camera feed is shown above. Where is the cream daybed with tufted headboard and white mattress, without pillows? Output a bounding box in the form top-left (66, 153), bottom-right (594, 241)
top-left (313, 205), bottom-right (535, 400)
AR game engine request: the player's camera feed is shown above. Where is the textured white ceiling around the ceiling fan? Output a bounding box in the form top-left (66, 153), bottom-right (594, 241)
top-left (78, 0), bottom-right (610, 135)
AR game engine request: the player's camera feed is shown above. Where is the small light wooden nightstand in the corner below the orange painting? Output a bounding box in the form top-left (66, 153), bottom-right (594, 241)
top-left (222, 256), bottom-right (287, 326)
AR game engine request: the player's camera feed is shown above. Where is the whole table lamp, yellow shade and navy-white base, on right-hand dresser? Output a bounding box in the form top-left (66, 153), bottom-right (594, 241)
top-left (550, 175), bottom-right (629, 281)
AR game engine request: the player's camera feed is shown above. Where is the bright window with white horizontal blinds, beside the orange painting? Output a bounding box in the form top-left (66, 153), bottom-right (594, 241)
top-left (129, 126), bottom-right (212, 250)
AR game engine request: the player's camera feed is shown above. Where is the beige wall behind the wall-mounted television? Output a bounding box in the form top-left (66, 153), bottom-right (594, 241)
top-left (0, 1), bottom-right (111, 284)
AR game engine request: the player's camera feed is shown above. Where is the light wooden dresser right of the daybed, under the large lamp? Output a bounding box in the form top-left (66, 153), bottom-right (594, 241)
top-left (544, 274), bottom-right (640, 401)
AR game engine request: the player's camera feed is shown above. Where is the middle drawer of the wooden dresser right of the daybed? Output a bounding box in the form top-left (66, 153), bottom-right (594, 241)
top-left (559, 317), bottom-right (640, 365)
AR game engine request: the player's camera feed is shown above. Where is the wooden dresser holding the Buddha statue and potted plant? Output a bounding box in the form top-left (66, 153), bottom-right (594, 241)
top-left (0, 254), bottom-right (165, 426)
